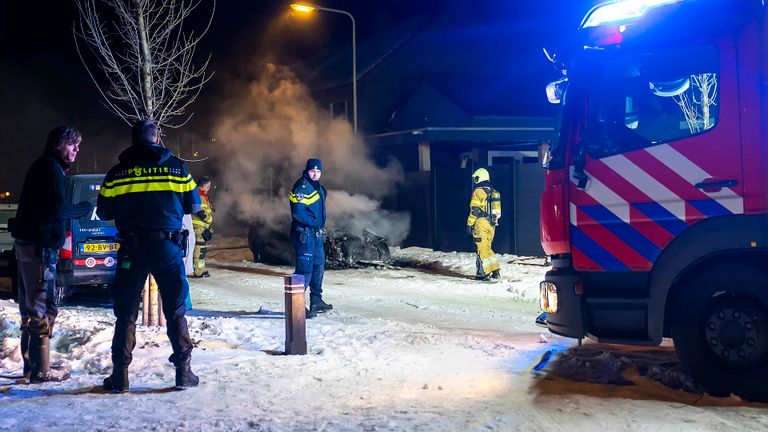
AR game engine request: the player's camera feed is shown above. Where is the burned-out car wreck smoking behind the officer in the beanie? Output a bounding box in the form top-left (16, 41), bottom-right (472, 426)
top-left (248, 224), bottom-right (390, 268)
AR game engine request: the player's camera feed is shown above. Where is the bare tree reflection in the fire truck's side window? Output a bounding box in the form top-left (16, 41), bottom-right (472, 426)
top-left (675, 73), bottom-right (717, 134)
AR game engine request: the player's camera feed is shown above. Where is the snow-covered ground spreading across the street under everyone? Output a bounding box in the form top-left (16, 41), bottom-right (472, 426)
top-left (0, 248), bottom-right (768, 432)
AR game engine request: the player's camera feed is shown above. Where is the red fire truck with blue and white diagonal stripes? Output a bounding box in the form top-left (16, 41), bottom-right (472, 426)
top-left (540, 0), bottom-right (768, 401)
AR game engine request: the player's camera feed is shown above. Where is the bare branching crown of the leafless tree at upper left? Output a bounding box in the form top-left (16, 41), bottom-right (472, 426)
top-left (73, 0), bottom-right (216, 128)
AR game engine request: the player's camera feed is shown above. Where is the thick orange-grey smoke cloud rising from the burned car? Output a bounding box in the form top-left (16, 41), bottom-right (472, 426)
top-left (213, 64), bottom-right (410, 244)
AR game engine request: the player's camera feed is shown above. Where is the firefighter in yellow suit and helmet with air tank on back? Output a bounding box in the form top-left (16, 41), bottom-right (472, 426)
top-left (467, 168), bottom-right (501, 281)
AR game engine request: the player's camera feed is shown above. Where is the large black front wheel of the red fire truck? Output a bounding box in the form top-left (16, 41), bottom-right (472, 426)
top-left (672, 265), bottom-right (768, 402)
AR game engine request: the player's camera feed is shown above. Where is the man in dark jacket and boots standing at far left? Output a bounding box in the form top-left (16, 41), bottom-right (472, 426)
top-left (9, 126), bottom-right (93, 383)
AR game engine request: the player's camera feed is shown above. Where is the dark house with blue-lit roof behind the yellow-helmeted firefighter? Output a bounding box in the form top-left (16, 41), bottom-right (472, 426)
top-left (298, 9), bottom-right (557, 255)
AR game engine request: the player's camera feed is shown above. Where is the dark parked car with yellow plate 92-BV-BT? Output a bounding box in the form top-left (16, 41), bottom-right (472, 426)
top-left (56, 174), bottom-right (120, 303)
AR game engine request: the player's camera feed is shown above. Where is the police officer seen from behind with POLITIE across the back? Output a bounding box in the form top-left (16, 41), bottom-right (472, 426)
top-left (97, 120), bottom-right (200, 393)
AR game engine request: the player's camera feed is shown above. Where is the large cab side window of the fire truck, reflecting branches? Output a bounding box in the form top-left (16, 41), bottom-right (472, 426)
top-left (560, 45), bottom-right (719, 158)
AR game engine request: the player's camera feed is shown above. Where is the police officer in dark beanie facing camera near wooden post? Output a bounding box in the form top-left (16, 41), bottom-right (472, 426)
top-left (289, 158), bottom-right (333, 318)
